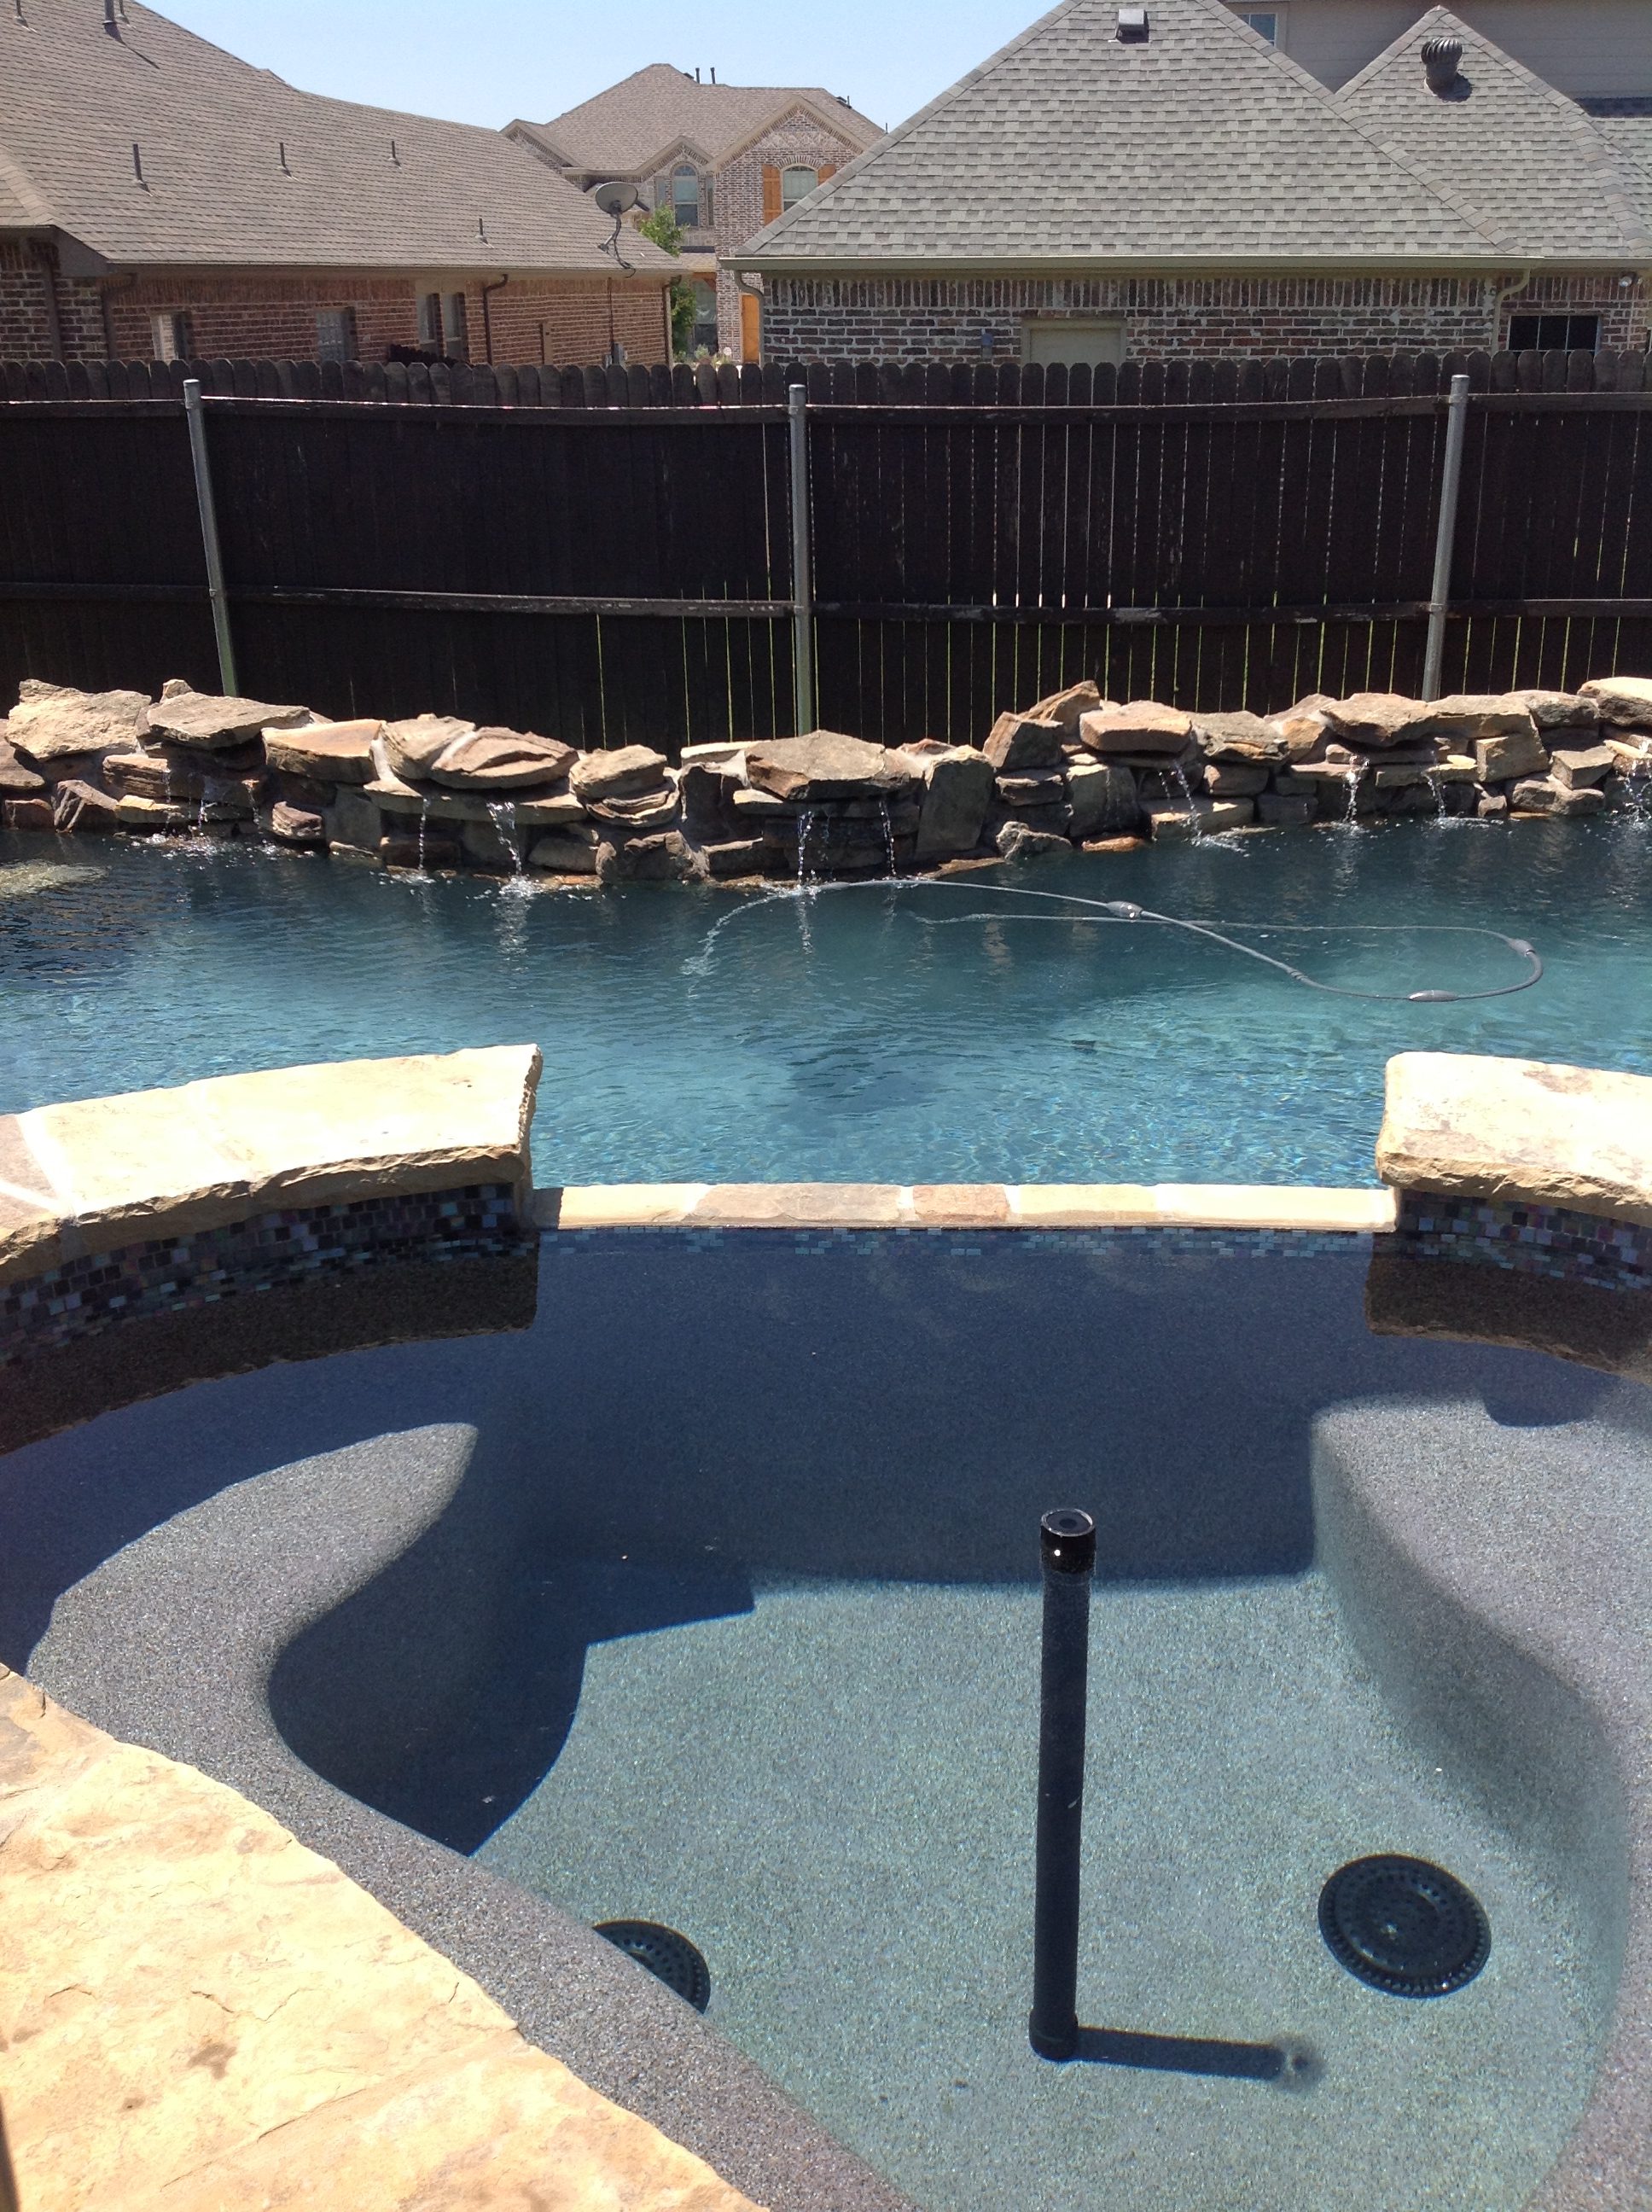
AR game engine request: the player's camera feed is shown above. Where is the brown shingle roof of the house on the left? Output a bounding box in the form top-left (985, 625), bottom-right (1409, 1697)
top-left (0, 0), bottom-right (672, 276)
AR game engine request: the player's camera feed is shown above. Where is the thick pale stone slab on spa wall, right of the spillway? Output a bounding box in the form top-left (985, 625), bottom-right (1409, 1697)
top-left (1376, 1053), bottom-right (1652, 1228)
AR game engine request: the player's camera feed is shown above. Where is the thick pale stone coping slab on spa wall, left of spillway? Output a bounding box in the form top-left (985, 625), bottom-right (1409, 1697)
top-left (0, 1044), bottom-right (539, 1283)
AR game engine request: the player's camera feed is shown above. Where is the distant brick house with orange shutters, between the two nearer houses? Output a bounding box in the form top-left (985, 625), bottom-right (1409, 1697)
top-left (506, 62), bottom-right (882, 360)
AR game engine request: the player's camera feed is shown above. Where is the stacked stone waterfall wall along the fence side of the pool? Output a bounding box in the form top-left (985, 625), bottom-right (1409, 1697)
top-left (0, 677), bottom-right (1652, 885)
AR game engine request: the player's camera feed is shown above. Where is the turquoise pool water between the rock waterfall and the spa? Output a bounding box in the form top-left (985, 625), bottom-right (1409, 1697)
top-left (0, 821), bottom-right (1652, 1184)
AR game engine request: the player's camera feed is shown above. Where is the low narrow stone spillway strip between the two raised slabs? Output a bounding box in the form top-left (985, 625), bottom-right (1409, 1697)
top-left (533, 1184), bottom-right (1395, 1237)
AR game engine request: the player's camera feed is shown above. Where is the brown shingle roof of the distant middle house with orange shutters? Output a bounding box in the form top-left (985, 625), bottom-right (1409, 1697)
top-left (524, 62), bottom-right (882, 177)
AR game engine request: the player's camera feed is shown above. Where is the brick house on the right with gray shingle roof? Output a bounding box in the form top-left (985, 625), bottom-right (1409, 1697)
top-left (725, 0), bottom-right (1652, 360)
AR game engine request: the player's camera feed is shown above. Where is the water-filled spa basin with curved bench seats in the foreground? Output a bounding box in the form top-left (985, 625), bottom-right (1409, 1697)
top-left (0, 1232), bottom-right (1652, 2212)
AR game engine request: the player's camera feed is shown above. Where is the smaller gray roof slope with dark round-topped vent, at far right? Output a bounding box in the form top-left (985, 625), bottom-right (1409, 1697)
top-left (1335, 7), bottom-right (1652, 261)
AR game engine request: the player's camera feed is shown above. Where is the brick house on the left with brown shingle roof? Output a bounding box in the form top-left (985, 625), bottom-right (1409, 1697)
top-left (0, 0), bottom-right (677, 360)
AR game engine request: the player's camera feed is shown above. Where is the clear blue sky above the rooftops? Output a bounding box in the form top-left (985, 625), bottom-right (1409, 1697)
top-left (154, 0), bottom-right (1048, 128)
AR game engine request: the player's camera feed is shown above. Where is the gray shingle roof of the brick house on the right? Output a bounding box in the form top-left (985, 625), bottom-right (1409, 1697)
top-left (732, 0), bottom-right (1652, 274)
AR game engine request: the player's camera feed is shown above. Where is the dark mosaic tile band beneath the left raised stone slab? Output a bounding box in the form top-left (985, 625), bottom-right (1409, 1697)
top-left (0, 1184), bottom-right (533, 1367)
